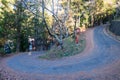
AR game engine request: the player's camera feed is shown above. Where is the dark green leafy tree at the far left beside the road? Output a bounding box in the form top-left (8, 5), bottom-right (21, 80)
top-left (0, 0), bottom-right (33, 51)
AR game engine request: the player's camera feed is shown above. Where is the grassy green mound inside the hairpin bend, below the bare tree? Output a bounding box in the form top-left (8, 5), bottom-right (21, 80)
top-left (39, 34), bottom-right (86, 60)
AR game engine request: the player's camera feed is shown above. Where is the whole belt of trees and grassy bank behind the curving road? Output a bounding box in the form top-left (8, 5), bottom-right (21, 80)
top-left (0, 0), bottom-right (120, 57)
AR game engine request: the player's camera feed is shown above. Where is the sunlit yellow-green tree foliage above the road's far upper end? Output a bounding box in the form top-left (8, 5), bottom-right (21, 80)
top-left (62, 0), bottom-right (115, 27)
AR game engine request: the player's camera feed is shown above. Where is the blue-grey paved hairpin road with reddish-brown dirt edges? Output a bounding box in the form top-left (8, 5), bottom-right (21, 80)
top-left (2, 27), bottom-right (120, 80)
